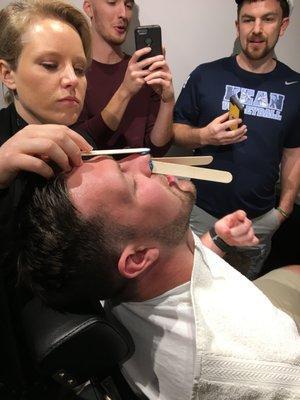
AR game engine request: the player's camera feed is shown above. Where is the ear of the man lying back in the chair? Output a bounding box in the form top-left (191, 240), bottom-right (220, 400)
top-left (118, 245), bottom-right (159, 279)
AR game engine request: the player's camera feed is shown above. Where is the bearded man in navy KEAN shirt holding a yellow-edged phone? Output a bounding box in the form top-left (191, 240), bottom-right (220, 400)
top-left (174, 0), bottom-right (300, 279)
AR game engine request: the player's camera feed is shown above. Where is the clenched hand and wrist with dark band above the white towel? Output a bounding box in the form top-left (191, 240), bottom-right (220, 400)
top-left (201, 210), bottom-right (259, 257)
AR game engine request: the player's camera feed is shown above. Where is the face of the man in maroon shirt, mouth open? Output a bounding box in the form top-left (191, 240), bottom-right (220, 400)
top-left (84, 0), bottom-right (134, 45)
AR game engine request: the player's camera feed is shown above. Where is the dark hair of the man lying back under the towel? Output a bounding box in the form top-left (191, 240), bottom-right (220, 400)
top-left (18, 175), bottom-right (132, 312)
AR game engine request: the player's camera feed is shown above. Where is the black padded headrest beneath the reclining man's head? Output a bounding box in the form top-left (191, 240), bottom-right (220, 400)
top-left (23, 298), bottom-right (134, 387)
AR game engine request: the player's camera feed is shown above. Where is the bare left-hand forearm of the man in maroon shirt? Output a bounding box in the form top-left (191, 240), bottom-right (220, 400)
top-left (101, 84), bottom-right (131, 131)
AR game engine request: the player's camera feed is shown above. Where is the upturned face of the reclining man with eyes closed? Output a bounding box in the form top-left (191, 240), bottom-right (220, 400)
top-left (67, 155), bottom-right (195, 239)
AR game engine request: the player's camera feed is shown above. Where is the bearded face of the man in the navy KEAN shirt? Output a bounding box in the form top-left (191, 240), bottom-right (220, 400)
top-left (236, 0), bottom-right (289, 60)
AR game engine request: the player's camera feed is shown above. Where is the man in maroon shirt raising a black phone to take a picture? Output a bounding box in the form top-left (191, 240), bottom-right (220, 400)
top-left (76, 0), bottom-right (175, 155)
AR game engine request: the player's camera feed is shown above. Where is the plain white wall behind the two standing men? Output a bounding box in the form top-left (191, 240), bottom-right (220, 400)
top-left (0, 0), bottom-right (300, 106)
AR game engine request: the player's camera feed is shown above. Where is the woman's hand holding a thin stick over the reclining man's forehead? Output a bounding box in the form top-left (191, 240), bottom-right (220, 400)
top-left (0, 125), bottom-right (92, 188)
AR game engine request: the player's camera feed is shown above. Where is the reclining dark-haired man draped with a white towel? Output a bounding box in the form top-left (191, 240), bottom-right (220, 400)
top-left (19, 156), bottom-right (300, 400)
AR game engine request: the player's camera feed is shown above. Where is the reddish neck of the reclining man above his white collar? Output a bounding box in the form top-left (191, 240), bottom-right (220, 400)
top-left (122, 230), bottom-right (195, 301)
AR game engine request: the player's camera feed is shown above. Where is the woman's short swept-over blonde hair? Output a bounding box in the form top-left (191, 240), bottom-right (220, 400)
top-left (0, 0), bottom-right (92, 104)
